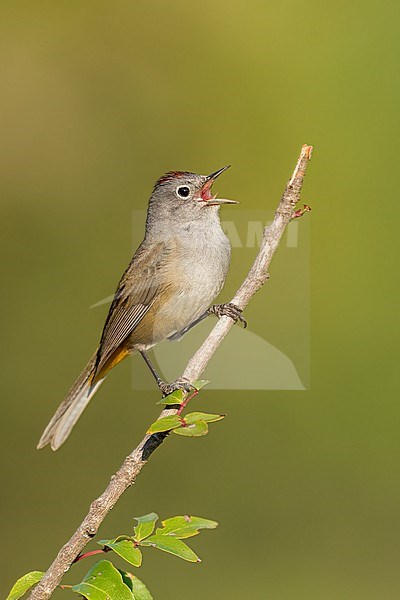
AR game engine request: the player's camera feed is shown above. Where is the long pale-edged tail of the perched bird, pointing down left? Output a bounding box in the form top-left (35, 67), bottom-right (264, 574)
top-left (37, 351), bottom-right (104, 450)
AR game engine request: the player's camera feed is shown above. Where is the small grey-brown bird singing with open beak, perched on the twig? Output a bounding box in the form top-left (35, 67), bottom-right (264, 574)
top-left (38, 165), bottom-right (246, 450)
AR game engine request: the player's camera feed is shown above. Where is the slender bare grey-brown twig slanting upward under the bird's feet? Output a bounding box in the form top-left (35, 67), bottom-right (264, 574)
top-left (29, 145), bottom-right (312, 600)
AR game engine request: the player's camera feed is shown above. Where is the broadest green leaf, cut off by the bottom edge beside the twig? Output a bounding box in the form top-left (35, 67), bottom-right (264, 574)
top-left (72, 560), bottom-right (134, 600)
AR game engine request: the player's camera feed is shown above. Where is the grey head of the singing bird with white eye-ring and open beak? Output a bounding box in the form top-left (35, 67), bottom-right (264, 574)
top-left (146, 165), bottom-right (237, 230)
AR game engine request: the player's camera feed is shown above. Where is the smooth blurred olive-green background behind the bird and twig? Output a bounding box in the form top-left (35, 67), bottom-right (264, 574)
top-left (0, 0), bottom-right (400, 600)
